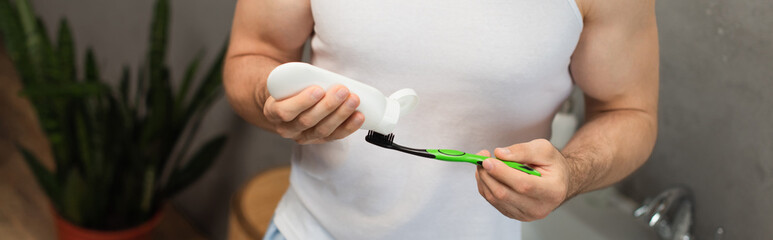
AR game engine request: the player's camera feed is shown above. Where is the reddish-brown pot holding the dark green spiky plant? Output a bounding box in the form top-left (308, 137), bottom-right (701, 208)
top-left (54, 209), bottom-right (163, 240)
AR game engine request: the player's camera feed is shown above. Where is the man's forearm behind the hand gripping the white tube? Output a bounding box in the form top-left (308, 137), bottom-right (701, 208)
top-left (223, 54), bottom-right (280, 131)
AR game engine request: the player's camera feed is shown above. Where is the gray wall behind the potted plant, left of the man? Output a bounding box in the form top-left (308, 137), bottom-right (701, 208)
top-left (32, 0), bottom-right (291, 239)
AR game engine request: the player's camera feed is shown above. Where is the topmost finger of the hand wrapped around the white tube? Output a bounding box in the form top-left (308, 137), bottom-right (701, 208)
top-left (263, 86), bottom-right (325, 123)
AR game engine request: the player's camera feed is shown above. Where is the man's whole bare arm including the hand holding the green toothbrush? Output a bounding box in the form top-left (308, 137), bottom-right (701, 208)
top-left (476, 0), bottom-right (658, 221)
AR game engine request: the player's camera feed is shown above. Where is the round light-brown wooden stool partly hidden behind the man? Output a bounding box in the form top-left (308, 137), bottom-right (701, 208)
top-left (228, 166), bottom-right (290, 240)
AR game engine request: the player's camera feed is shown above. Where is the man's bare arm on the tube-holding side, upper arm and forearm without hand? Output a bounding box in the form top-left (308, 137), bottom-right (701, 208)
top-left (223, 0), bottom-right (314, 130)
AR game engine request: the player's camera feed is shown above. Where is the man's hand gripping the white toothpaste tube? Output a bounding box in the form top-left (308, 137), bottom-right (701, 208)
top-left (263, 85), bottom-right (365, 144)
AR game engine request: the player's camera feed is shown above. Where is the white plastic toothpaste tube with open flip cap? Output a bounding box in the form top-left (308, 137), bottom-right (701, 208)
top-left (266, 62), bottom-right (419, 134)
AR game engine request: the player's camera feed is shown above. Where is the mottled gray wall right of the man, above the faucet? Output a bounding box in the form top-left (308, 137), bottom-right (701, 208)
top-left (621, 0), bottom-right (773, 239)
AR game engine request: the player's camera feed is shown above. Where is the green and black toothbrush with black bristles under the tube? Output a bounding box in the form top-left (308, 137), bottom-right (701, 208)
top-left (365, 131), bottom-right (542, 176)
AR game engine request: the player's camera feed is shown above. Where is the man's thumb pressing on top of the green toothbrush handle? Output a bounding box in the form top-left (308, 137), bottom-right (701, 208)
top-left (494, 139), bottom-right (558, 166)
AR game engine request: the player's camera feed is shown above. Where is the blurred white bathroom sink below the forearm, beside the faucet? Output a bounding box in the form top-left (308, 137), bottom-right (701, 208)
top-left (523, 187), bottom-right (658, 240)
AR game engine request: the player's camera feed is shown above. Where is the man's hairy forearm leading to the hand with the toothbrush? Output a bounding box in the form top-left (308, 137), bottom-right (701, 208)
top-left (561, 109), bottom-right (657, 199)
